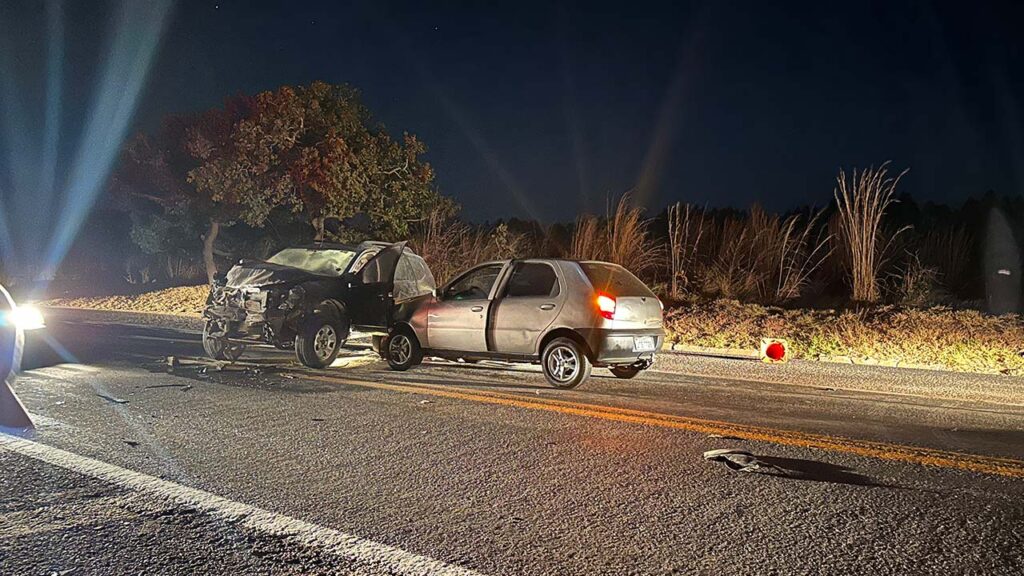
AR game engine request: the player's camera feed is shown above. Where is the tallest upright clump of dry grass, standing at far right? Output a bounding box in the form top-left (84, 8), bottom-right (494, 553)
top-left (834, 162), bottom-right (906, 302)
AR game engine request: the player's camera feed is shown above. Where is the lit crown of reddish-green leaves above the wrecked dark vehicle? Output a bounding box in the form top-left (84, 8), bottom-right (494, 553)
top-left (190, 82), bottom-right (443, 240)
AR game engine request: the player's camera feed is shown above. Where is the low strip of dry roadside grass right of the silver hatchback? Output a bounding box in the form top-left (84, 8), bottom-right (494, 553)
top-left (666, 300), bottom-right (1024, 374)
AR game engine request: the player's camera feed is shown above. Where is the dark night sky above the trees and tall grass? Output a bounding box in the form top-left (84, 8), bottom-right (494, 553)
top-left (6, 0), bottom-right (1024, 220)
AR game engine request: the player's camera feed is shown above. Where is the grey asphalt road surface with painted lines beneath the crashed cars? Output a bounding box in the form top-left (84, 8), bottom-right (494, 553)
top-left (0, 315), bottom-right (1024, 575)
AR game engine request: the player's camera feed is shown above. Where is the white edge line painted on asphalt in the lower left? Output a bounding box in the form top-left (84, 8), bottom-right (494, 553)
top-left (0, 433), bottom-right (479, 576)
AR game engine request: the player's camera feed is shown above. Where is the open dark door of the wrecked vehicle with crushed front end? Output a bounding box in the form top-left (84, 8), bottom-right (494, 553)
top-left (346, 242), bottom-right (406, 330)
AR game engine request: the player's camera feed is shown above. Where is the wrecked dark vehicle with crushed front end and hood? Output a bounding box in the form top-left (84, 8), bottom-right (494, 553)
top-left (203, 242), bottom-right (435, 368)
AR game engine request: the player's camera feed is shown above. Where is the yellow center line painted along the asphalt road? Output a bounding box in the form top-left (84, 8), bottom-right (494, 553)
top-left (304, 373), bottom-right (1024, 478)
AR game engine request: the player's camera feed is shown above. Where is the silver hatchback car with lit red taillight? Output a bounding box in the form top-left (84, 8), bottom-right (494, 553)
top-left (380, 259), bottom-right (665, 388)
